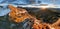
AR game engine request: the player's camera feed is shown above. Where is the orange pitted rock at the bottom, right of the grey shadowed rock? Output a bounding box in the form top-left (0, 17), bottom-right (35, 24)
top-left (33, 20), bottom-right (51, 29)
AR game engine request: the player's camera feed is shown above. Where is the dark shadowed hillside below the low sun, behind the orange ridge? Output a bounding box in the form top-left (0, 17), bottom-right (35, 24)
top-left (25, 8), bottom-right (60, 24)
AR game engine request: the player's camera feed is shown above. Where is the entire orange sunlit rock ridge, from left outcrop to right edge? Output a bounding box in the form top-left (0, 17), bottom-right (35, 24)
top-left (9, 5), bottom-right (60, 29)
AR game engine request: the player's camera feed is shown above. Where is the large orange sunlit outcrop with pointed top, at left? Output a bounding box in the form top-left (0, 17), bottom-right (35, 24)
top-left (9, 5), bottom-right (33, 22)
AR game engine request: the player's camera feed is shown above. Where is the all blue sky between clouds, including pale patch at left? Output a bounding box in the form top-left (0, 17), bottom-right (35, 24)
top-left (0, 0), bottom-right (60, 16)
